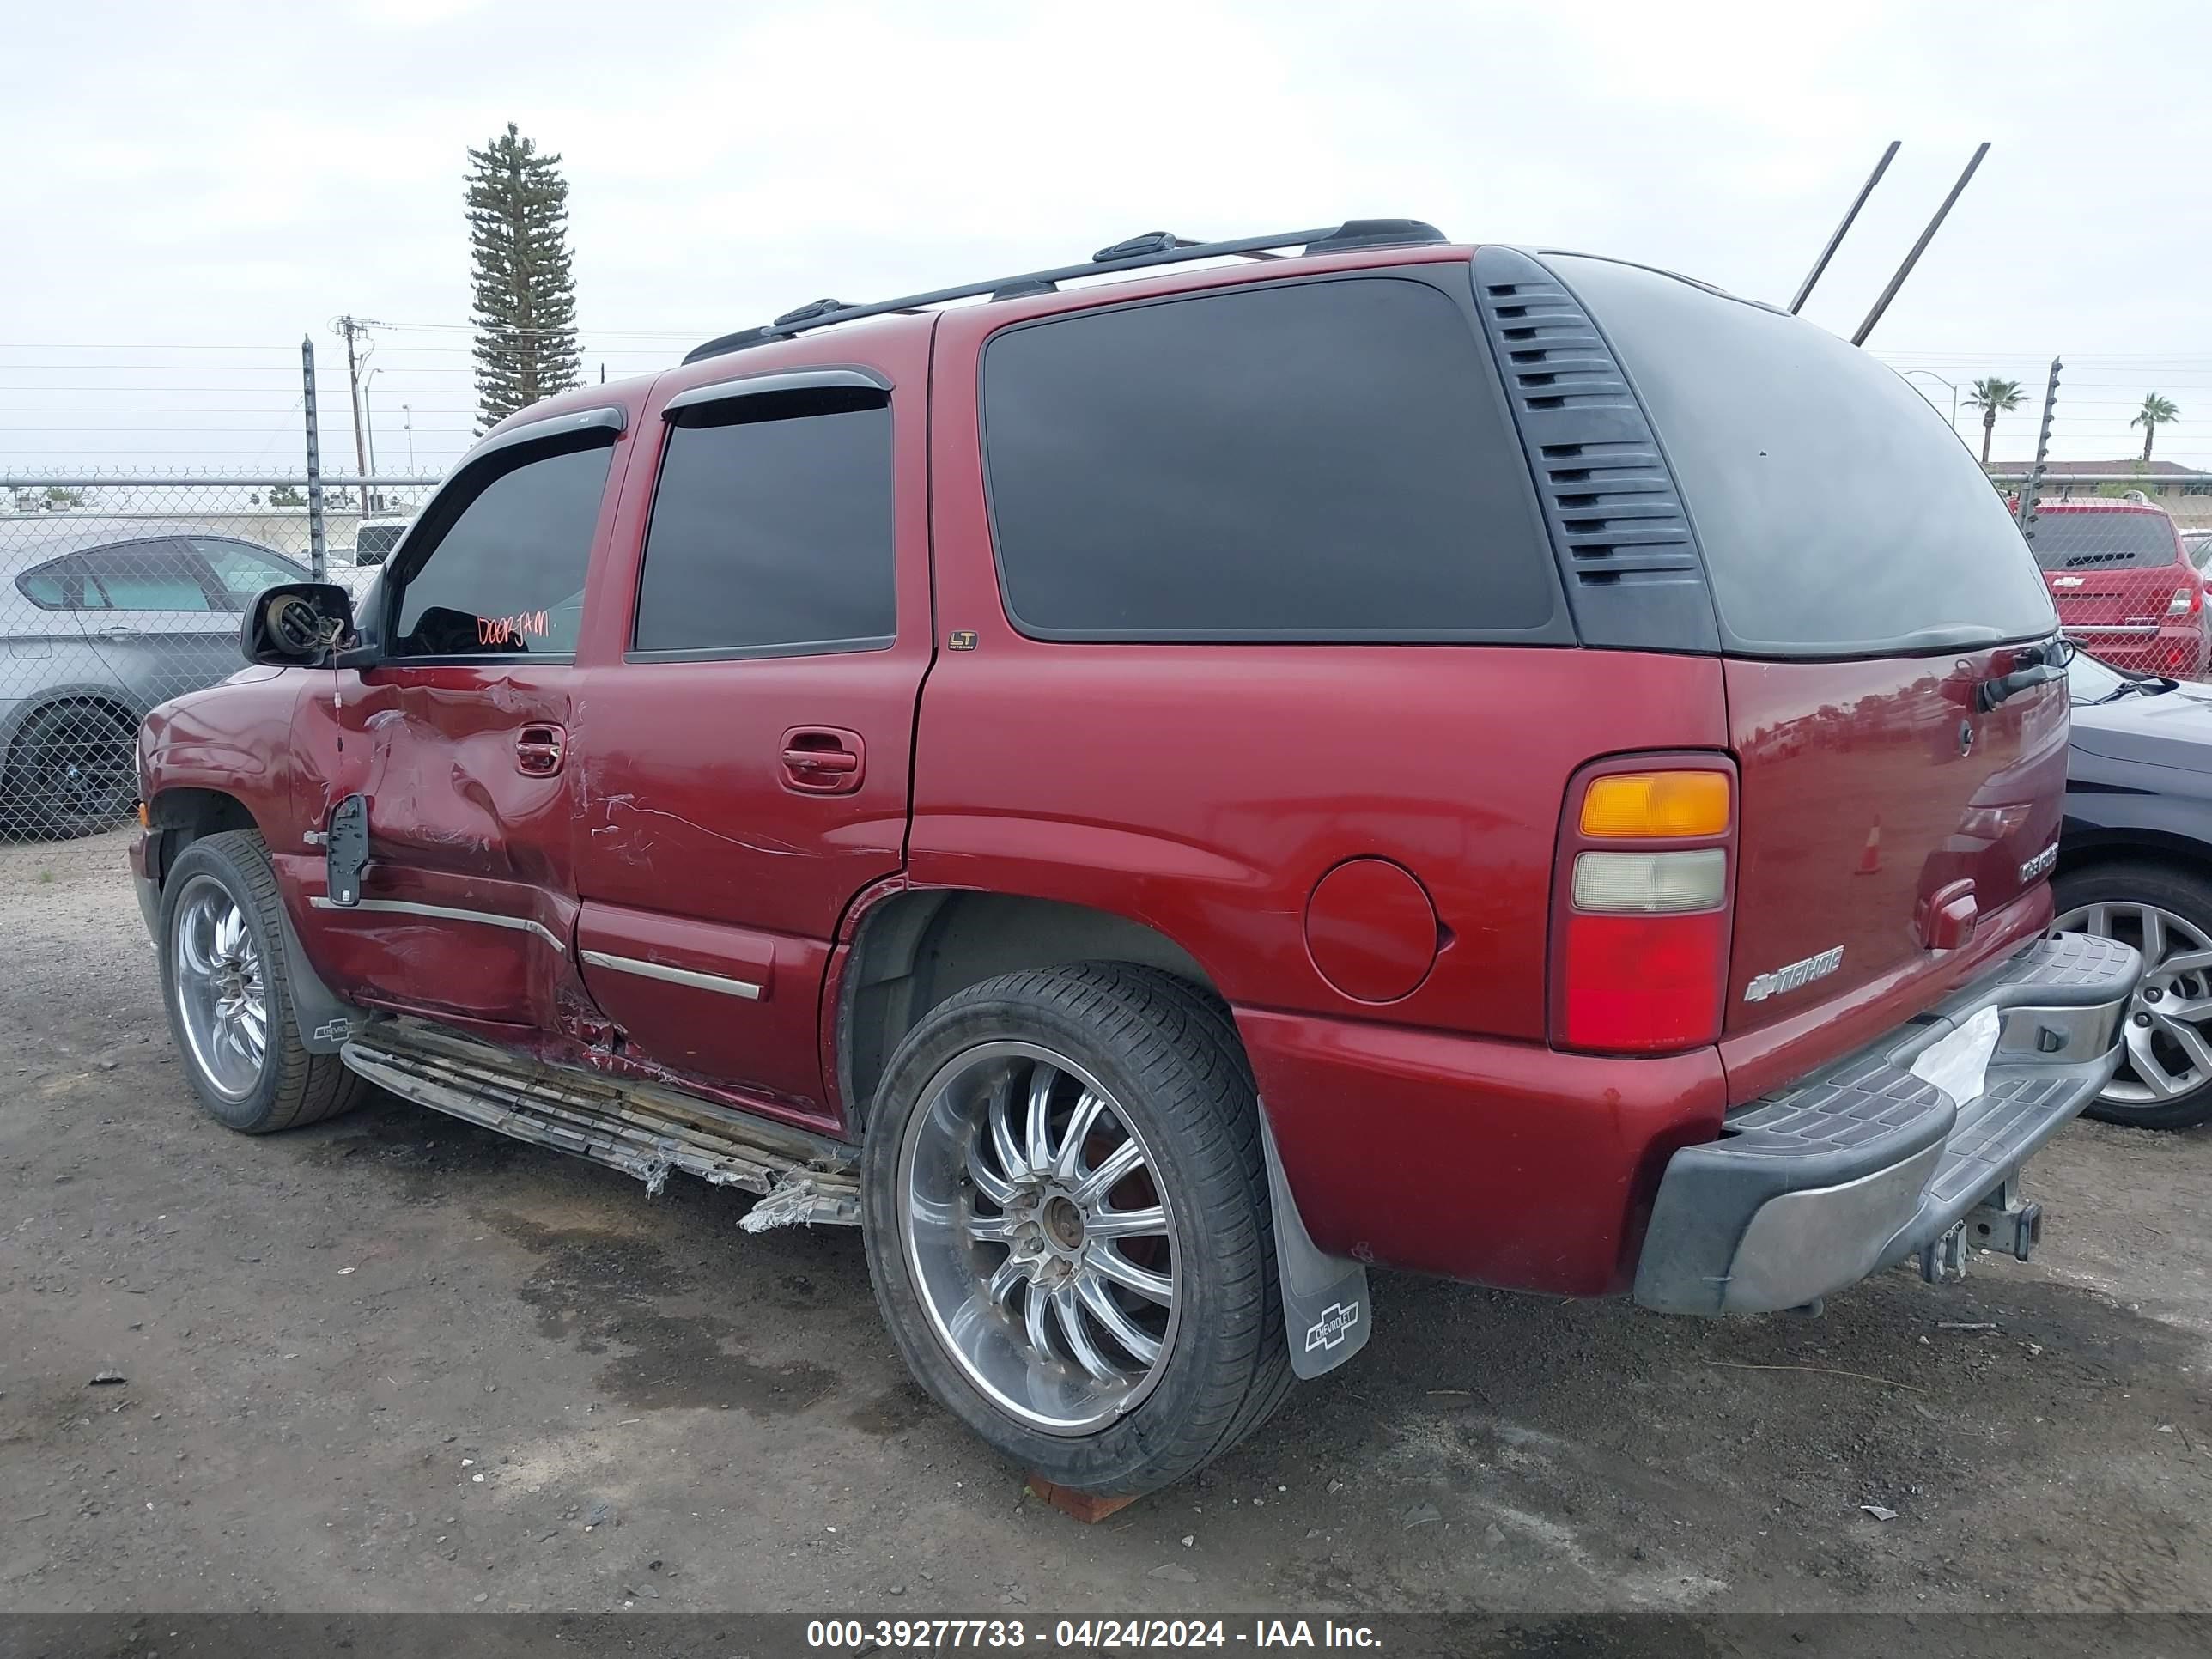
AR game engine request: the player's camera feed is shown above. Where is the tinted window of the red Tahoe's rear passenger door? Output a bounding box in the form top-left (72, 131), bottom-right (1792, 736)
top-left (637, 400), bottom-right (898, 654)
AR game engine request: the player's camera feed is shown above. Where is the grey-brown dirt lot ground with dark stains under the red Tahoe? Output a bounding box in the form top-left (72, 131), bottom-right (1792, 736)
top-left (0, 836), bottom-right (2212, 1614)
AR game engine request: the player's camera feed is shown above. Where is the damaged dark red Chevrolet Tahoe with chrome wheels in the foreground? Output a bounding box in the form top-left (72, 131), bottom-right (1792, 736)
top-left (133, 222), bottom-right (2136, 1493)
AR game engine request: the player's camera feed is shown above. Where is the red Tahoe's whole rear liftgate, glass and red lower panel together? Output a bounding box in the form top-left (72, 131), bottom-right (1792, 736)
top-left (1548, 257), bottom-right (2066, 1060)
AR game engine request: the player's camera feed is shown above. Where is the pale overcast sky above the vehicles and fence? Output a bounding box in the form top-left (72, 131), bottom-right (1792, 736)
top-left (0, 0), bottom-right (2212, 471)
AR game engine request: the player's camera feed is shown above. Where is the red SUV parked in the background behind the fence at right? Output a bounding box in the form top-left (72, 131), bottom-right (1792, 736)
top-left (2028, 500), bottom-right (2212, 679)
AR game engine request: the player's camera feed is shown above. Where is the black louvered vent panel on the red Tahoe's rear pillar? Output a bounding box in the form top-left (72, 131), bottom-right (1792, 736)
top-left (1474, 248), bottom-right (1717, 648)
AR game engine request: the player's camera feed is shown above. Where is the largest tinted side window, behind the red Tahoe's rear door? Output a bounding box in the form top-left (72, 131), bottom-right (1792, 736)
top-left (982, 279), bottom-right (1566, 639)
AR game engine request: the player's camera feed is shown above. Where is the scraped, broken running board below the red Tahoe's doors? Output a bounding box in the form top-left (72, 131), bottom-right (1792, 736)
top-left (338, 1020), bottom-right (860, 1232)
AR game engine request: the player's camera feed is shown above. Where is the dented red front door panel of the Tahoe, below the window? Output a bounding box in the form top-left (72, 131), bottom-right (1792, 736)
top-left (305, 664), bottom-right (575, 1026)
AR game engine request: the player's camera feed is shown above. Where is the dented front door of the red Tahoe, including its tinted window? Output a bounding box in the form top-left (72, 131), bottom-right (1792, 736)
top-left (285, 409), bottom-right (626, 1030)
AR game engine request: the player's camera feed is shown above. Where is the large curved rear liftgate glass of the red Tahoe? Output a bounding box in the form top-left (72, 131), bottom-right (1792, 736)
top-left (1547, 254), bottom-right (2057, 657)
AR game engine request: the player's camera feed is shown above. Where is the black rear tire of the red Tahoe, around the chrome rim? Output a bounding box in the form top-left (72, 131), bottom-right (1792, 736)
top-left (863, 963), bottom-right (1291, 1498)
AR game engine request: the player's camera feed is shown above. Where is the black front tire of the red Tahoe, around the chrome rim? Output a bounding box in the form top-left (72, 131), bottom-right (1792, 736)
top-left (157, 830), bottom-right (369, 1134)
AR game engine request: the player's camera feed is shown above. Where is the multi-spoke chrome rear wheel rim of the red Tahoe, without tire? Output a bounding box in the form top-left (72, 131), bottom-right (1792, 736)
top-left (898, 1042), bottom-right (1179, 1436)
